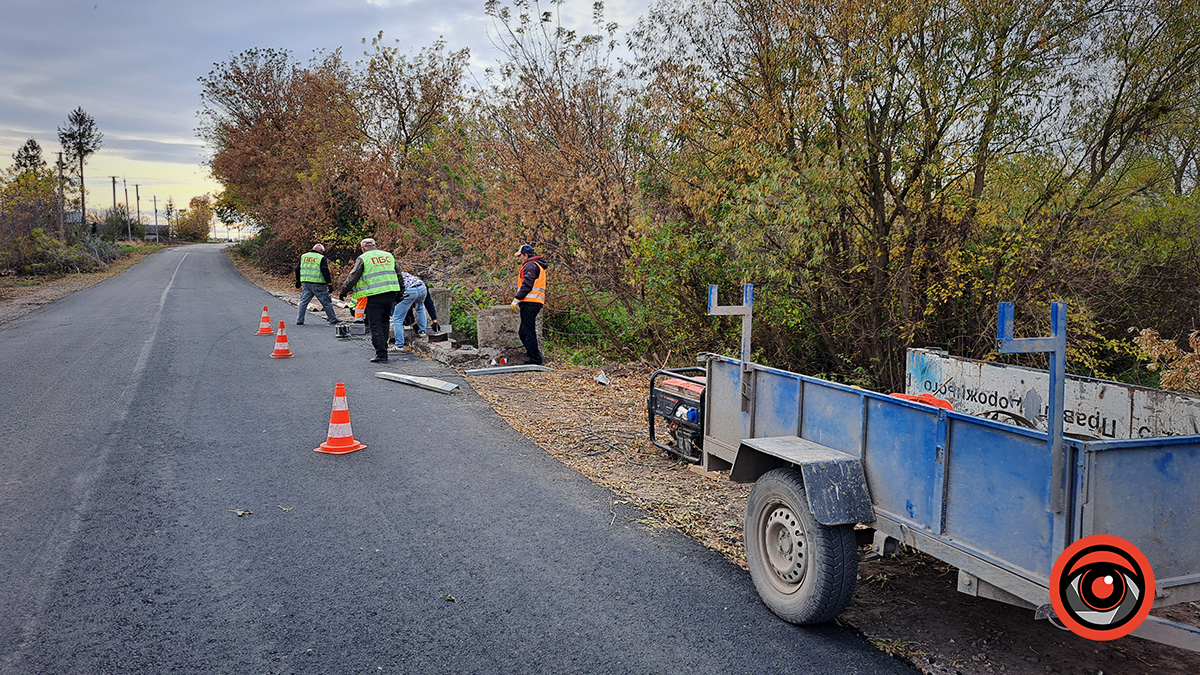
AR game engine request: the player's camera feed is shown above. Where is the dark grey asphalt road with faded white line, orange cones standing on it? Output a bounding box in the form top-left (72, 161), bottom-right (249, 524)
top-left (0, 245), bottom-right (912, 674)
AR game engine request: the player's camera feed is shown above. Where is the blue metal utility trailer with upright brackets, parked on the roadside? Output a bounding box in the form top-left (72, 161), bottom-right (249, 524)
top-left (649, 286), bottom-right (1200, 651)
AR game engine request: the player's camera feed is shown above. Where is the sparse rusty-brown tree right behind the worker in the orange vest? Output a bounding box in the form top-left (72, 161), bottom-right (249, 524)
top-left (468, 0), bottom-right (644, 353)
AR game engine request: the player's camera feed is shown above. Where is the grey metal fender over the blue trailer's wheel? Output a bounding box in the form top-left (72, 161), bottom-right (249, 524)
top-left (730, 436), bottom-right (875, 525)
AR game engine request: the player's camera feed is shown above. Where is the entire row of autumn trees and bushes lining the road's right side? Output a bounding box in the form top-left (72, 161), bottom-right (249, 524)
top-left (200, 0), bottom-right (1200, 389)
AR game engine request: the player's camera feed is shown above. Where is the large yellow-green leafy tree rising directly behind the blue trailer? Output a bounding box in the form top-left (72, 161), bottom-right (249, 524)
top-left (635, 0), bottom-right (1200, 388)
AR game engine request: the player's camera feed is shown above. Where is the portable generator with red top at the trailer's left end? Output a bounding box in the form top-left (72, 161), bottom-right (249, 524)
top-left (646, 366), bottom-right (708, 464)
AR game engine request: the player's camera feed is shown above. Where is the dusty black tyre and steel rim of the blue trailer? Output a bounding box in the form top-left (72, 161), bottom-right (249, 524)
top-left (743, 467), bottom-right (858, 623)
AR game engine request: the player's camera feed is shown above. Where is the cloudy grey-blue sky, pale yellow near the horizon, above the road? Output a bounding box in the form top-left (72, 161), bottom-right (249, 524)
top-left (0, 0), bottom-right (648, 214)
